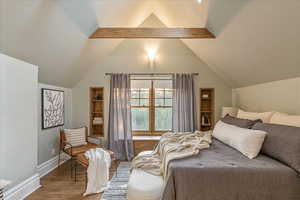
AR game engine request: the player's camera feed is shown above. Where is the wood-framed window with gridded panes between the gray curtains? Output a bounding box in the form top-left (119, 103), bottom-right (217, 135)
top-left (131, 80), bottom-right (173, 135)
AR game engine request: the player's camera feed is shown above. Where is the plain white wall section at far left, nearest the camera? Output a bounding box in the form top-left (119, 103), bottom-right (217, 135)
top-left (0, 54), bottom-right (38, 190)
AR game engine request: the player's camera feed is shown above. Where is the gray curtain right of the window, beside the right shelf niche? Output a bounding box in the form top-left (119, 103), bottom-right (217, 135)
top-left (172, 74), bottom-right (197, 132)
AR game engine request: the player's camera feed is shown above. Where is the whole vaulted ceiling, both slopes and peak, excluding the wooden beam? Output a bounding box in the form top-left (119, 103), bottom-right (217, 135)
top-left (0, 0), bottom-right (300, 88)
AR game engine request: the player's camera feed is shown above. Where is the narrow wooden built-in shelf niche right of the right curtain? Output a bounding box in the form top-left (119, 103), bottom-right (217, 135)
top-left (200, 88), bottom-right (214, 131)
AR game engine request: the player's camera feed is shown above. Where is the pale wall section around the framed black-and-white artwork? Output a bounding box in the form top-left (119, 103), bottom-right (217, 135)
top-left (37, 83), bottom-right (72, 164)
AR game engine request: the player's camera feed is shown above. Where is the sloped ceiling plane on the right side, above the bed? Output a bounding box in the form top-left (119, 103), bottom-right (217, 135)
top-left (185, 0), bottom-right (300, 87)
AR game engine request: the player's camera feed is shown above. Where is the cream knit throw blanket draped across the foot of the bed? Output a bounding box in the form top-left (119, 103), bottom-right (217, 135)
top-left (132, 131), bottom-right (212, 178)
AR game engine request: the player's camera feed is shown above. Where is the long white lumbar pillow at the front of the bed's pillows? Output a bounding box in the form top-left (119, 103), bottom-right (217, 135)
top-left (213, 121), bottom-right (267, 159)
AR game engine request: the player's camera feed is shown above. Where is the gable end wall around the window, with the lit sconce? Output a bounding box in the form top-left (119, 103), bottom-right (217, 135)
top-left (72, 16), bottom-right (231, 144)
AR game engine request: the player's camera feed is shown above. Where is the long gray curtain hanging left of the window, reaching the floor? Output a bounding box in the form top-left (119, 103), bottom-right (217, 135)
top-left (108, 74), bottom-right (133, 160)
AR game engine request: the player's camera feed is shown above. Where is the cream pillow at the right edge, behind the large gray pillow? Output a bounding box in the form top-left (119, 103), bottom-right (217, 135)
top-left (270, 112), bottom-right (300, 127)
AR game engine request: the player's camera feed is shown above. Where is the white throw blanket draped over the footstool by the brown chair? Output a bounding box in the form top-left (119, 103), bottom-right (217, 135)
top-left (83, 148), bottom-right (111, 196)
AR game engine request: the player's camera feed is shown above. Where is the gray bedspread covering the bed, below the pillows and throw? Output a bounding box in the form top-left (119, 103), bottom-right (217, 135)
top-left (163, 140), bottom-right (300, 200)
